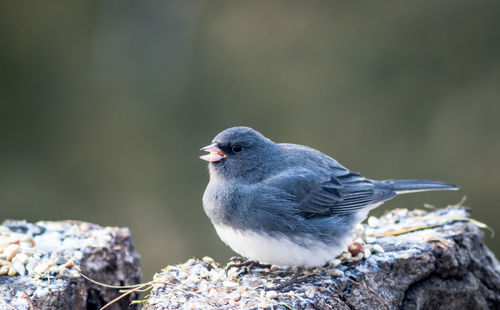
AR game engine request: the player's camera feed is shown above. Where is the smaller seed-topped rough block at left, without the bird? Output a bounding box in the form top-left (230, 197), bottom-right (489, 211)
top-left (0, 221), bottom-right (140, 310)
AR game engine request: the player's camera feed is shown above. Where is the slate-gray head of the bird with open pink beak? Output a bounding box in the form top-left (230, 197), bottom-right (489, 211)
top-left (200, 127), bottom-right (279, 182)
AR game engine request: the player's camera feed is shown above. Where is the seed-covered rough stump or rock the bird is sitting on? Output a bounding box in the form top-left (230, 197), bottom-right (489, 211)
top-left (141, 207), bottom-right (500, 310)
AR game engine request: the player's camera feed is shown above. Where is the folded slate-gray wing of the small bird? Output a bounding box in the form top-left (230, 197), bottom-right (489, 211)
top-left (264, 166), bottom-right (396, 218)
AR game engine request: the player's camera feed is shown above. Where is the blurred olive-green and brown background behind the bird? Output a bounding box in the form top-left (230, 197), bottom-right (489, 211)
top-left (0, 0), bottom-right (500, 280)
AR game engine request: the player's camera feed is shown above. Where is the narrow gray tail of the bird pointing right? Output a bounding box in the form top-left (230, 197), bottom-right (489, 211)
top-left (374, 180), bottom-right (460, 194)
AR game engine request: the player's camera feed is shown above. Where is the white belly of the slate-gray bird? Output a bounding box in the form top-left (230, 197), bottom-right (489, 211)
top-left (215, 225), bottom-right (347, 267)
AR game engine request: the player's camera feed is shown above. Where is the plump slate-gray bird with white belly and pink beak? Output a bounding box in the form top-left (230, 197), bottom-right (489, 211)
top-left (200, 127), bottom-right (458, 266)
